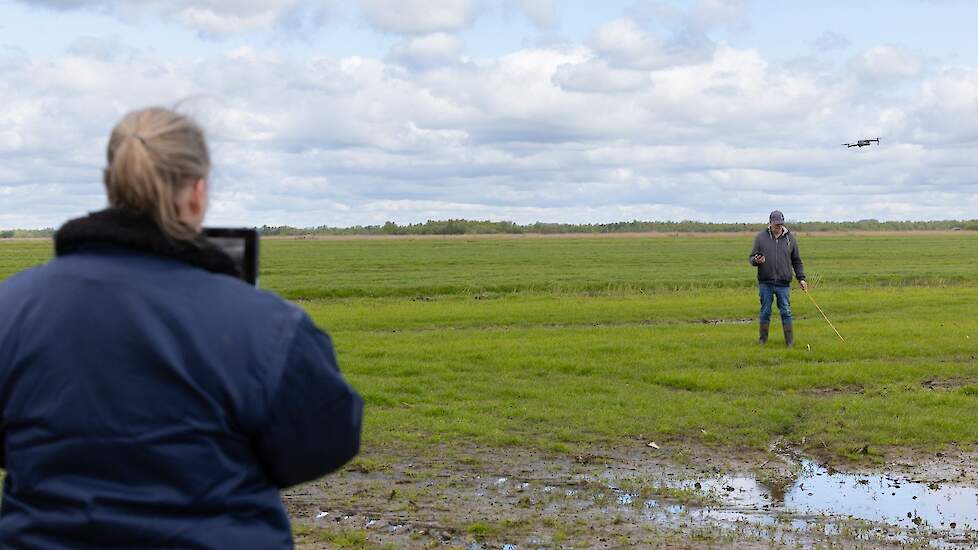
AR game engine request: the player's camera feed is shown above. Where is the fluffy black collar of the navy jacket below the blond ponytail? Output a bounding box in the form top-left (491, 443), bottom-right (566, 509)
top-left (54, 208), bottom-right (238, 277)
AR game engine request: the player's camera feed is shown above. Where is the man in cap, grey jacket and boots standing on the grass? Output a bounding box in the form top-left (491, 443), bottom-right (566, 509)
top-left (750, 210), bottom-right (808, 348)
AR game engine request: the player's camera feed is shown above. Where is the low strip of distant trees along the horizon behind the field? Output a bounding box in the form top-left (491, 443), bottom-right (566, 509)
top-left (0, 219), bottom-right (978, 239)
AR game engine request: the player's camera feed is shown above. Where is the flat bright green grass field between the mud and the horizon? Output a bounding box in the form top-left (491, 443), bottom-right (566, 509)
top-left (0, 233), bottom-right (978, 458)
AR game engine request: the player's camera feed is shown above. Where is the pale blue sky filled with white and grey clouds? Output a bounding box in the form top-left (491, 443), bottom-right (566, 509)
top-left (0, 0), bottom-right (978, 228)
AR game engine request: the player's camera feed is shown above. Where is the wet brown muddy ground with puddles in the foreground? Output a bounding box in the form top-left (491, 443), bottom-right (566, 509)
top-left (283, 439), bottom-right (978, 550)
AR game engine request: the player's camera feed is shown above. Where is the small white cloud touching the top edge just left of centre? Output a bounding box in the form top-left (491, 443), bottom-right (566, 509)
top-left (358, 0), bottom-right (476, 34)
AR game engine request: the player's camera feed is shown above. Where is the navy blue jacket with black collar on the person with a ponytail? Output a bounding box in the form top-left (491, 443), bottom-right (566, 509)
top-left (0, 210), bottom-right (362, 549)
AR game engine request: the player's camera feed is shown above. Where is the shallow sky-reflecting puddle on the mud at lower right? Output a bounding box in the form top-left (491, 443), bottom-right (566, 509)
top-left (471, 460), bottom-right (978, 550)
